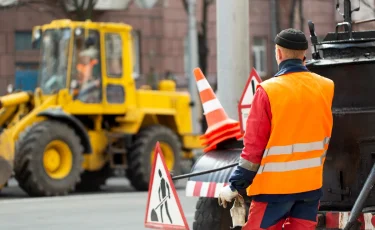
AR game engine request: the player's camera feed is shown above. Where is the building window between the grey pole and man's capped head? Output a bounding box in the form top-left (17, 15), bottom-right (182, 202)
top-left (253, 37), bottom-right (267, 77)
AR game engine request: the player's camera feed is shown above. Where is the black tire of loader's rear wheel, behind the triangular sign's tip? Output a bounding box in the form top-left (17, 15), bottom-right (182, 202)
top-left (126, 125), bottom-right (182, 191)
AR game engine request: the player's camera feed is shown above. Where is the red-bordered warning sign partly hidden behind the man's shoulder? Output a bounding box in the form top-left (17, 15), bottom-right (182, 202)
top-left (238, 68), bottom-right (262, 132)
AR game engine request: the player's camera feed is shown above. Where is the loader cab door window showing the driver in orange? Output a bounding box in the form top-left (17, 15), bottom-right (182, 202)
top-left (71, 28), bottom-right (102, 103)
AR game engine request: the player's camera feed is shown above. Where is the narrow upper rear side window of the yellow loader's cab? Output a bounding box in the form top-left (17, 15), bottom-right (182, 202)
top-left (105, 33), bottom-right (123, 78)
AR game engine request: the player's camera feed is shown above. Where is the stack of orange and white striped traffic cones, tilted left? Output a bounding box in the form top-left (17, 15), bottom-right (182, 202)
top-left (193, 68), bottom-right (242, 152)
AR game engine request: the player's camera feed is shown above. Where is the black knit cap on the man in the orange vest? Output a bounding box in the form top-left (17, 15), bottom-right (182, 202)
top-left (275, 28), bottom-right (308, 50)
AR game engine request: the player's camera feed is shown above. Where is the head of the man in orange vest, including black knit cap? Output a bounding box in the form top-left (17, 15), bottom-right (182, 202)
top-left (275, 28), bottom-right (308, 64)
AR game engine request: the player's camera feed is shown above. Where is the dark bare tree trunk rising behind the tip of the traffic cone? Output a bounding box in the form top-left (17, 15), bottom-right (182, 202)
top-left (182, 0), bottom-right (215, 82)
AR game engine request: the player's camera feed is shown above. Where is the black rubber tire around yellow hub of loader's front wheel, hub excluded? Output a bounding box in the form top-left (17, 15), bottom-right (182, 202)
top-left (14, 120), bottom-right (83, 196)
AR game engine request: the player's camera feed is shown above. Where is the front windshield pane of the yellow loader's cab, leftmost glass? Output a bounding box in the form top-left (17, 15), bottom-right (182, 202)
top-left (38, 28), bottom-right (71, 94)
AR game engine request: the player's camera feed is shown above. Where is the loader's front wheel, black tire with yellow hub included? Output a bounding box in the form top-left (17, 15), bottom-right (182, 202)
top-left (14, 121), bottom-right (83, 196)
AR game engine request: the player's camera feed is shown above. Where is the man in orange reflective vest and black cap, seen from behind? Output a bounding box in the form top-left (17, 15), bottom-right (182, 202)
top-left (219, 29), bottom-right (334, 230)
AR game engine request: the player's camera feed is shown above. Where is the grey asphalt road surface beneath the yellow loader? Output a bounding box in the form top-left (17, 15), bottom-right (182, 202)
top-left (0, 178), bottom-right (197, 230)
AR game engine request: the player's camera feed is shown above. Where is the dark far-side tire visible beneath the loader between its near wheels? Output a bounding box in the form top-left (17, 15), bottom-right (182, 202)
top-left (76, 164), bottom-right (111, 192)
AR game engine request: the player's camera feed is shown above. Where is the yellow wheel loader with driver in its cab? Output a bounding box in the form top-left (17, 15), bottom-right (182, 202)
top-left (0, 20), bottom-right (202, 196)
